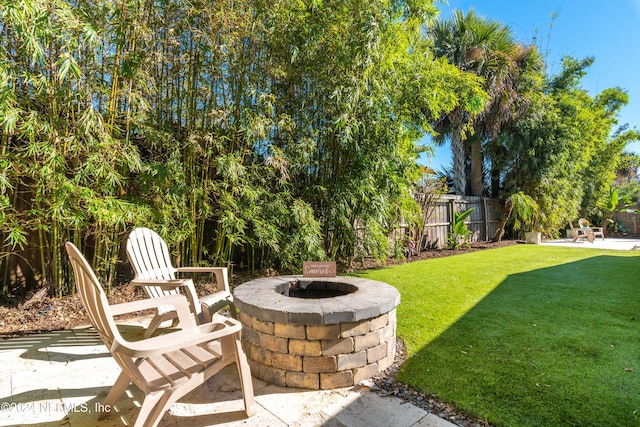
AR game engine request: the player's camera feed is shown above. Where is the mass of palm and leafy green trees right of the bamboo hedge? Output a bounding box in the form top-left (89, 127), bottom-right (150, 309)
top-left (428, 9), bottom-right (638, 236)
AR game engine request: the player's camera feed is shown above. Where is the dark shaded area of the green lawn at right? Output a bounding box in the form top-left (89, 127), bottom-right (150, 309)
top-left (399, 256), bottom-right (640, 426)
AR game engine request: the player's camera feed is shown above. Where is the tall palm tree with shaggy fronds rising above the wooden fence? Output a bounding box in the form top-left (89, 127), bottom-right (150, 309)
top-left (429, 9), bottom-right (542, 196)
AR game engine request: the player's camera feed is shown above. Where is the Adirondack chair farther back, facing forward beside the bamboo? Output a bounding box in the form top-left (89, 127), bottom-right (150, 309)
top-left (127, 227), bottom-right (237, 337)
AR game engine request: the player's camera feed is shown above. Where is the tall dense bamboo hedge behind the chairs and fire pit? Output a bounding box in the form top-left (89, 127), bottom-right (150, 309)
top-left (0, 0), bottom-right (460, 293)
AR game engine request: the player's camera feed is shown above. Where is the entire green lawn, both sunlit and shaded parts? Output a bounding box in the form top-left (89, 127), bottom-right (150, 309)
top-left (361, 245), bottom-right (640, 426)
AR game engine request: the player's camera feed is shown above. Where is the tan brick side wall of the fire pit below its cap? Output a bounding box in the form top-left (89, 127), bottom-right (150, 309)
top-left (240, 309), bottom-right (397, 389)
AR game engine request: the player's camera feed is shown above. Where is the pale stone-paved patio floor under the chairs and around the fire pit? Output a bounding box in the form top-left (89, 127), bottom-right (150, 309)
top-left (0, 322), bottom-right (453, 427)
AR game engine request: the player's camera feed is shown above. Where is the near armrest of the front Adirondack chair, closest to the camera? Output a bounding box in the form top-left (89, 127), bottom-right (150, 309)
top-left (110, 317), bottom-right (242, 358)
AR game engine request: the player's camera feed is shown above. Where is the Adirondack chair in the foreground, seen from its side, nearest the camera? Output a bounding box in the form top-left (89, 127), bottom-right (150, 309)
top-left (66, 242), bottom-right (257, 427)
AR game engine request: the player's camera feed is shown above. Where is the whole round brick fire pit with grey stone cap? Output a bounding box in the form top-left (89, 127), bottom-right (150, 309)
top-left (233, 276), bottom-right (400, 389)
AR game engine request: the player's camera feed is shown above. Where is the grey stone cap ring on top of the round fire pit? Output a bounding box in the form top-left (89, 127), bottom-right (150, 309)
top-left (233, 276), bottom-right (400, 325)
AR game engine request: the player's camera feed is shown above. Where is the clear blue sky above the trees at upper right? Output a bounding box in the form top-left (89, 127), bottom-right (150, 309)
top-left (421, 0), bottom-right (640, 170)
